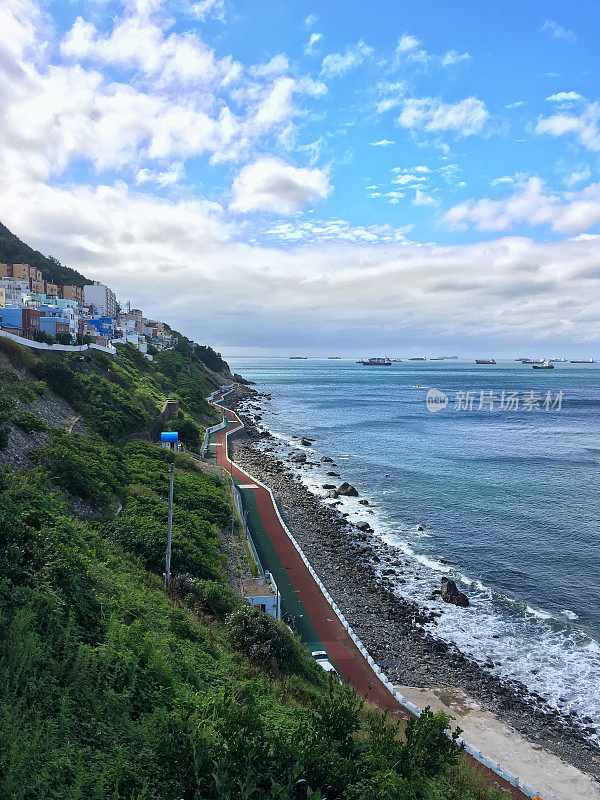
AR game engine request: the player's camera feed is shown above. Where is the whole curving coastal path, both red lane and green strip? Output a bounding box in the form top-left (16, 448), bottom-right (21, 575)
top-left (208, 387), bottom-right (541, 800)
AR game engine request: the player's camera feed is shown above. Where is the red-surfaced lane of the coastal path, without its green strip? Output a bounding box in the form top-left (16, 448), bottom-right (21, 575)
top-left (210, 393), bottom-right (528, 800)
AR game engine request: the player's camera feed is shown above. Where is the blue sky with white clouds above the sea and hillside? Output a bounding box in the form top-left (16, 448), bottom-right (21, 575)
top-left (0, 0), bottom-right (600, 357)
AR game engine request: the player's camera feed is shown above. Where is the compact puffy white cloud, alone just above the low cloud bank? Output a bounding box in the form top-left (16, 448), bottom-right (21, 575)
top-left (230, 158), bottom-right (331, 216)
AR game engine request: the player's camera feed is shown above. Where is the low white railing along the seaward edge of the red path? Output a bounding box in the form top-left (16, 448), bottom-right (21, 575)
top-left (207, 392), bottom-right (551, 800)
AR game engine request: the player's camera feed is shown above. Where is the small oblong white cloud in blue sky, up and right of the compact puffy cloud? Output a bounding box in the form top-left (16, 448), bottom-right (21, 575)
top-left (398, 97), bottom-right (489, 136)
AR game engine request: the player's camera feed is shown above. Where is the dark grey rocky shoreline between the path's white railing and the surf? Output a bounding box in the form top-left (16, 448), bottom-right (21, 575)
top-left (227, 389), bottom-right (600, 779)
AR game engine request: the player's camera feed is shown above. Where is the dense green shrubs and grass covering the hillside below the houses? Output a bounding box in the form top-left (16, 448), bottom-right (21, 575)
top-left (0, 340), bottom-right (506, 800)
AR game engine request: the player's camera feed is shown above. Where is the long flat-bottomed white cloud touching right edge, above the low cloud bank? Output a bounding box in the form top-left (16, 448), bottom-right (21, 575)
top-left (444, 178), bottom-right (600, 234)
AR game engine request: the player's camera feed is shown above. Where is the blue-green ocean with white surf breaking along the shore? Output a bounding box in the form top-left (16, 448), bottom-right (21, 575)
top-left (229, 358), bottom-right (600, 742)
